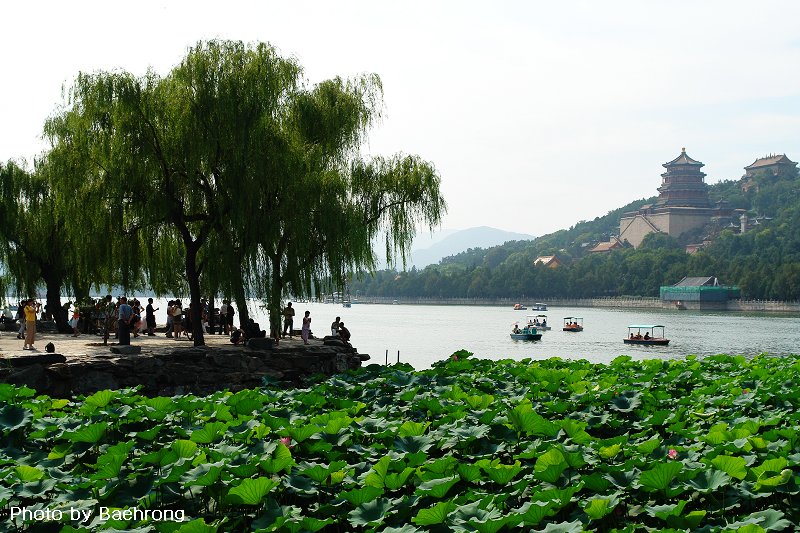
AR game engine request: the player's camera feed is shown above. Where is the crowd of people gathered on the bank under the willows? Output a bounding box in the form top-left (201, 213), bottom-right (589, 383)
top-left (3, 295), bottom-right (350, 350)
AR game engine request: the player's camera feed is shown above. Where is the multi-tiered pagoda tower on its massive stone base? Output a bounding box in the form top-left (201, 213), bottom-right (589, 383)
top-left (619, 148), bottom-right (739, 247)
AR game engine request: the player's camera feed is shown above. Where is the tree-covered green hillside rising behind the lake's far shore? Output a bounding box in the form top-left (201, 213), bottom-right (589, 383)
top-left (352, 164), bottom-right (800, 300)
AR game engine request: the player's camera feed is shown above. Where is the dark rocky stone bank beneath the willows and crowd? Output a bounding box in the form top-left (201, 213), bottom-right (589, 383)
top-left (0, 336), bottom-right (369, 398)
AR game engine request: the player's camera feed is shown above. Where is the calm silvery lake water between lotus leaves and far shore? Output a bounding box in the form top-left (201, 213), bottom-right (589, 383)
top-left (247, 303), bottom-right (800, 370)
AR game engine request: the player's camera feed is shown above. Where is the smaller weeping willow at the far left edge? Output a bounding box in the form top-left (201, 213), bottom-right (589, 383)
top-left (0, 157), bottom-right (83, 332)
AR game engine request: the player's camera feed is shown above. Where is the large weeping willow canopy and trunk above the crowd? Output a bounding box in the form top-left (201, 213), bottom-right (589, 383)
top-left (46, 41), bottom-right (444, 345)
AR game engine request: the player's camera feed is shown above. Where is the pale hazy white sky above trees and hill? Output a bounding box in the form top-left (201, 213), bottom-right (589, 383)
top-left (0, 0), bottom-right (800, 235)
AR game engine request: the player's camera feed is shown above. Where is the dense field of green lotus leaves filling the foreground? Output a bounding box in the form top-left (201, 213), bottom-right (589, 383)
top-left (0, 351), bottom-right (800, 533)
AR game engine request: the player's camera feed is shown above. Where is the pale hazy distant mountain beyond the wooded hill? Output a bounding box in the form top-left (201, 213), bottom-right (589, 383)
top-left (410, 226), bottom-right (535, 268)
